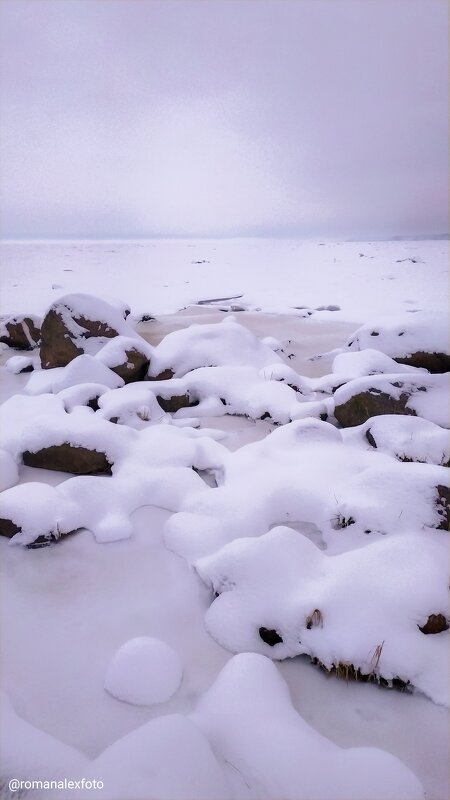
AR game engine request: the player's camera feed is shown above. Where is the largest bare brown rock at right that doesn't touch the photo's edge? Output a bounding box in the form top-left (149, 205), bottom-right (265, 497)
top-left (334, 389), bottom-right (416, 428)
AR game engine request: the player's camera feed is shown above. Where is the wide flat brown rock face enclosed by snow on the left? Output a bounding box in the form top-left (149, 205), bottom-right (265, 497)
top-left (22, 442), bottom-right (112, 475)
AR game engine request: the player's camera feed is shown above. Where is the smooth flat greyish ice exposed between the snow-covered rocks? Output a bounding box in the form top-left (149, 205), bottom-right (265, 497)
top-left (0, 272), bottom-right (448, 800)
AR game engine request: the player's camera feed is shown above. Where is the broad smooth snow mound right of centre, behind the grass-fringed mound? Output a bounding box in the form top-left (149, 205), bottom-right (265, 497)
top-left (165, 419), bottom-right (448, 560)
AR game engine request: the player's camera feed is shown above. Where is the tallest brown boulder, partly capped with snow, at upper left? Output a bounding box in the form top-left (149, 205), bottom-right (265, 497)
top-left (40, 294), bottom-right (135, 369)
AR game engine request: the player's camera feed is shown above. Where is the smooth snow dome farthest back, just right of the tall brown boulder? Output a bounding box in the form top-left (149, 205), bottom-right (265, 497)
top-left (149, 317), bottom-right (281, 377)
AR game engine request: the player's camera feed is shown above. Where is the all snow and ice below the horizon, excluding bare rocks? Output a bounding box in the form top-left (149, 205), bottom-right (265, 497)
top-left (0, 240), bottom-right (450, 800)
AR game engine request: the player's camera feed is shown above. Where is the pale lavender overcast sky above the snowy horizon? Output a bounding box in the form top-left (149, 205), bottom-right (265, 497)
top-left (0, 0), bottom-right (448, 238)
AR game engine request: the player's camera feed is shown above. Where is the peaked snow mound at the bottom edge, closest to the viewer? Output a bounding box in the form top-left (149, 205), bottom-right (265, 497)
top-left (93, 653), bottom-right (423, 800)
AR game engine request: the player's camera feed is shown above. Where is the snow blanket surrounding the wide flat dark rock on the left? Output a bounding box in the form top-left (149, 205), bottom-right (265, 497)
top-left (0, 418), bottom-right (228, 545)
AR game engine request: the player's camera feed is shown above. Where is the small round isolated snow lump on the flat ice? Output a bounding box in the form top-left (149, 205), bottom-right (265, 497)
top-left (105, 636), bottom-right (183, 706)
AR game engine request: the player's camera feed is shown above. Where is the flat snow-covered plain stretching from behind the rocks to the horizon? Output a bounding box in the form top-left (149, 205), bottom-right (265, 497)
top-left (0, 239), bottom-right (449, 323)
